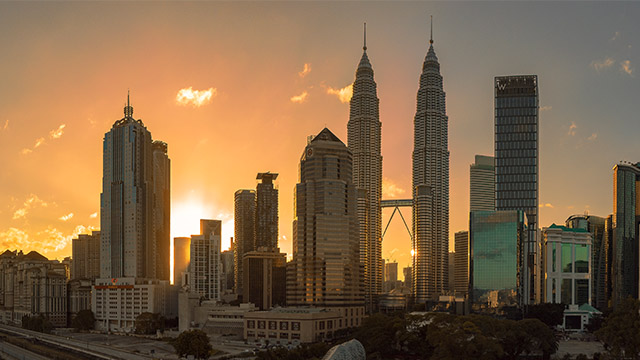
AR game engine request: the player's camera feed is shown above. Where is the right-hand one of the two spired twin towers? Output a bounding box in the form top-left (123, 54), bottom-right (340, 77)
top-left (412, 22), bottom-right (449, 303)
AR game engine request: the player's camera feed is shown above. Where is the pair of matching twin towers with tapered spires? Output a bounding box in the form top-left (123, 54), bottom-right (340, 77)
top-left (347, 21), bottom-right (449, 310)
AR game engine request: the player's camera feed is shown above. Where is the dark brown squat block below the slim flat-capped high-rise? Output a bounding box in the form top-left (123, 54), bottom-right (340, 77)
top-left (242, 247), bottom-right (287, 310)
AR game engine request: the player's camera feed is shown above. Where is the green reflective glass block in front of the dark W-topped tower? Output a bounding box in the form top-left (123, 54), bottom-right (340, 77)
top-left (469, 210), bottom-right (528, 310)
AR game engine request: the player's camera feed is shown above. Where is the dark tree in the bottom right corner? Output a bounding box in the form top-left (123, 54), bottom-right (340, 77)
top-left (595, 297), bottom-right (640, 359)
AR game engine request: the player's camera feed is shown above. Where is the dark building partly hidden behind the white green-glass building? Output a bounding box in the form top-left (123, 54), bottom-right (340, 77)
top-left (565, 214), bottom-right (611, 310)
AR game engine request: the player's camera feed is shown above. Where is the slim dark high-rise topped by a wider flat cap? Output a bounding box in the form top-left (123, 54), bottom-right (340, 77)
top-left (252, 172), bottom-right (278, 250)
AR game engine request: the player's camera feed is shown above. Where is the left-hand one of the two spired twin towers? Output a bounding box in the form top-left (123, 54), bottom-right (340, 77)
top-left (347, 24), bottom-right (383, 311)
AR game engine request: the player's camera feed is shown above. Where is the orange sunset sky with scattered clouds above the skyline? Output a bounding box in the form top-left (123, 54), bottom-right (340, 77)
top-left (0, 2), bottom-right (640, 274)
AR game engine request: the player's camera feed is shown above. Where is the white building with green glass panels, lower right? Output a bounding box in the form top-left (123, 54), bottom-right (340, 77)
top-left (542, 224), bottom-right (592, 306)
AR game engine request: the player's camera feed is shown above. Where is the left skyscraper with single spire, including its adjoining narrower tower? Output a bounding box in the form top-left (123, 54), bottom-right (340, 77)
top-left (100, 97), bottom-right (170, 280)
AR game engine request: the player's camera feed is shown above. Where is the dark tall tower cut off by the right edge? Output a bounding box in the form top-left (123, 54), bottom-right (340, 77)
top-left (611, 163), bottom-right (640, 307)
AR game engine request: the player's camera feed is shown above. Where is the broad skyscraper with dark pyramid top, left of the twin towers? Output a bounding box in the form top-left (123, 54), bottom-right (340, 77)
top-left (287, 128), bottom-right (364, 310)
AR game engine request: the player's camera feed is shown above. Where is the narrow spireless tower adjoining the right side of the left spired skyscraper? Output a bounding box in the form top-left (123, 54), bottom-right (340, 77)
top-left (151, 140), bottom-right (171, 280)
